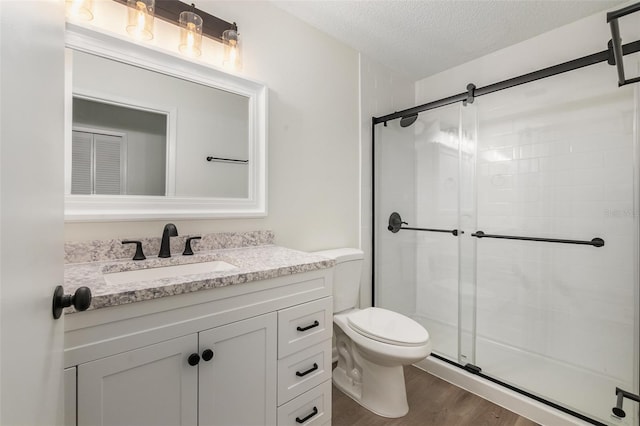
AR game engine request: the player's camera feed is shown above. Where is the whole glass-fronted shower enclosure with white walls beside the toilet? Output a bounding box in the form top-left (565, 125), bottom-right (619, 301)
top-left (373, 59), bottom-right (640, 426)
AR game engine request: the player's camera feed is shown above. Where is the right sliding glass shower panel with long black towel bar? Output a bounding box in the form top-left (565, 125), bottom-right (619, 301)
top-left (476, 60), bottom-right (638, 425)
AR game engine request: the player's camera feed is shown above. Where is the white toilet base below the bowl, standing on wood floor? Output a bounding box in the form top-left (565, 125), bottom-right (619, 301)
top-left (333, 356), bottom-right (409, 418)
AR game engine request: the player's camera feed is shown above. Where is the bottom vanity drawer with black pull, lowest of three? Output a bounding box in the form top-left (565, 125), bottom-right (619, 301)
top-left (278, 380), bottom-right (331, 426)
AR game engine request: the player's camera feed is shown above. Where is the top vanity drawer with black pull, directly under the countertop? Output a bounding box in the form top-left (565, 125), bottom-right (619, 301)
top-left (278, 297), bottom-right (333, 358)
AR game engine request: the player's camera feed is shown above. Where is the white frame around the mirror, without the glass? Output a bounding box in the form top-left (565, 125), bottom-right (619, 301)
top-left (65, 23), bottom-right (268, 222)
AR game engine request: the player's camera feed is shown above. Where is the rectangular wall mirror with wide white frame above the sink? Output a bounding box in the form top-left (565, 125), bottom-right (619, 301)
top-left (65, 24), bottom-right (267, 221)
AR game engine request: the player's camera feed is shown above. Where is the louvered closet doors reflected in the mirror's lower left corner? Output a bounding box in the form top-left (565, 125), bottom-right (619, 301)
top-left (71, 130), bottom-right (126, 195)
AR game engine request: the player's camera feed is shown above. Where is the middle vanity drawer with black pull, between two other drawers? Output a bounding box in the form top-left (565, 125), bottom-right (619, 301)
top-left (278, 339), bottom-right (331, 405)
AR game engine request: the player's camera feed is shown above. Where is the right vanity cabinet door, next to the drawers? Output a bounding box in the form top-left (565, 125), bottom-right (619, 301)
top-left (199, 312), bottom-right (277, 426)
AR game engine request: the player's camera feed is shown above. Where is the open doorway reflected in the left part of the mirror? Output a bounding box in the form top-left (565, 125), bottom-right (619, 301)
top-left (71, 97), bottom-right (167, 195)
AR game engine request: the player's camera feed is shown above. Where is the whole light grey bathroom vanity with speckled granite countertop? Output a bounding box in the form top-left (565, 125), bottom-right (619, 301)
top-left (64, 234), bottom-right (334, 426)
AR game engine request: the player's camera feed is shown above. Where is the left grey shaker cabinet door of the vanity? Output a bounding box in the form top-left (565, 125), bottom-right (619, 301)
top-left (77, 334), bottom-right (198, 426)
